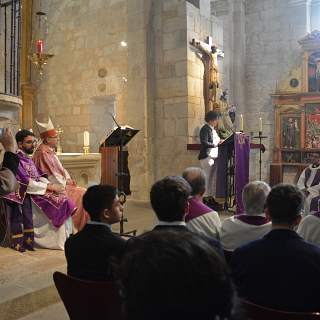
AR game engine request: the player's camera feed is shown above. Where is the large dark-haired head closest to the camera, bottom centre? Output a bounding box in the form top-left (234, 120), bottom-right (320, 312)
top-left (115, 230), bottom-right (237, 320)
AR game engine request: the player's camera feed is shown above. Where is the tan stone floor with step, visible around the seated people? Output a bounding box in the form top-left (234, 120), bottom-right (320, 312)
top-left (0, 197), bottom-right (233, 320)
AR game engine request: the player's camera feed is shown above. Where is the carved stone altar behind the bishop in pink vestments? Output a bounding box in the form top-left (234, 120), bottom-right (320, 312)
top-left (58, 153), bottom-right (101, 189)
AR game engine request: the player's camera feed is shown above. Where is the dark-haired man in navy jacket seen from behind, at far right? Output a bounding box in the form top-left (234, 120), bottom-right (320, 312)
top-left (231, 184), bottom-right (320, 312)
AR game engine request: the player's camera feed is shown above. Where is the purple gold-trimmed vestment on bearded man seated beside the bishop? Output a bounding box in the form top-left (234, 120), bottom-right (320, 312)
top-left (4, 153), bottom-right (77, 229)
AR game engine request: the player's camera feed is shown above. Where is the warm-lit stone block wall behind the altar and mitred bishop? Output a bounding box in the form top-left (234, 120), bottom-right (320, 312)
top-left (33, 0), bottom-right (128, 152)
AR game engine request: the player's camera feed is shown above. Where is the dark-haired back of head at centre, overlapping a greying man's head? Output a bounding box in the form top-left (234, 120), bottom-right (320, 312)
top-left (150, 176), bottom-right (191, 222)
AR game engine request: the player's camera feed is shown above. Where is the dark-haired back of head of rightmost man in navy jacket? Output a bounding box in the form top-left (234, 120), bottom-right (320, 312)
top-left (267, 183), bottom-right (305, 226)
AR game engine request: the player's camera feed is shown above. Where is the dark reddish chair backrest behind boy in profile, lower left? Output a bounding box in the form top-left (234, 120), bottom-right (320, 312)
top-left (53, 271), bottom-right (121, 320)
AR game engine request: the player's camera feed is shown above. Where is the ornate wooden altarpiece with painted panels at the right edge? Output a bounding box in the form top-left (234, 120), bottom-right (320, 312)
top-left (270, 30), bottom-right (320, 186)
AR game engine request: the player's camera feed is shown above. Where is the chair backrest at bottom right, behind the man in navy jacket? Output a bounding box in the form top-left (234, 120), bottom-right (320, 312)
top-left (239, 299), bottom-right (320, 320)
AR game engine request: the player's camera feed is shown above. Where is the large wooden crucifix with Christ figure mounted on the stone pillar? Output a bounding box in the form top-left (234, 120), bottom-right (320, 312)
top-left (192, 36), bottom-right (223, 113)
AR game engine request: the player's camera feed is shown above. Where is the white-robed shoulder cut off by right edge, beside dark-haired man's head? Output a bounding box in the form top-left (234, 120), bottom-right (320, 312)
top-left (297, 211), bottom-right (320, 247)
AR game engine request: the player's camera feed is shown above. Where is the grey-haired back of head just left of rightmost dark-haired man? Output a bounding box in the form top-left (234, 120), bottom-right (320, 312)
top-left (242, 181), bottom-right (271, 216)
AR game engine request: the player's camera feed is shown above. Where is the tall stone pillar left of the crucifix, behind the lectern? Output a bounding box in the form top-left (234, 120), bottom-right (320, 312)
top-left (128, 0), bottom-right (222, 199)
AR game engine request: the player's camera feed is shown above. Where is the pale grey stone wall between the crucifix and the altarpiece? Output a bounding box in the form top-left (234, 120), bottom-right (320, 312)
top-left (211, 0), bottom-right (319, 182)
